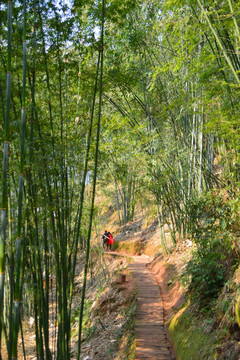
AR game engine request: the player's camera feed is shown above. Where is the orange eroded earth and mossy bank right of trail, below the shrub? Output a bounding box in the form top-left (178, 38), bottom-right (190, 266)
top-left (148, 252), bottom-right (240, 360)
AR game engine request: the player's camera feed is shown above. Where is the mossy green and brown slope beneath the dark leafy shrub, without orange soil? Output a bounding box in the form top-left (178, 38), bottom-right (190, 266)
top-left (168, 260), bottom-right (240, 360)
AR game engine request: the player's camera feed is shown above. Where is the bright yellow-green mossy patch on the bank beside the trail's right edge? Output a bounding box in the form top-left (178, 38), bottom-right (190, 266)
top-left (169, 305), bottom-right (221, 360)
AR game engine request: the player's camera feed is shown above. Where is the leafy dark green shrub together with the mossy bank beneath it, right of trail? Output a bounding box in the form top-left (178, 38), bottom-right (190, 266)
top-left (169, 192), bottom-right (240, 360)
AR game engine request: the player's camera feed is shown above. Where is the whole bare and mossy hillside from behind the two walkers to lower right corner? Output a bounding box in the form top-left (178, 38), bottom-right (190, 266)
top-left (94, 197), bottom-right (240, 360)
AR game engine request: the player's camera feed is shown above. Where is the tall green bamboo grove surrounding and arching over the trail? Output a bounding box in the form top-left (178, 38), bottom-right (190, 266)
top-left (0, 0), bottom-right (240, 360)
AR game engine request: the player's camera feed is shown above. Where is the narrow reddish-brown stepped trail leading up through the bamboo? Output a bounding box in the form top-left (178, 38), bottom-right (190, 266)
top-left (108, 253), bottom-right (174, 360)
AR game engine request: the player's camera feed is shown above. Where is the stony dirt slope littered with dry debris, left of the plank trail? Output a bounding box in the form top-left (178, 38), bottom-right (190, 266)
top-left (73, 256), bottom-right (136, 360)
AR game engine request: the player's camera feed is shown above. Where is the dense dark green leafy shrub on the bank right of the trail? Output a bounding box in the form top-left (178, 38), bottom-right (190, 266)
top-left (186, 193), bottom-right (237, 302)
